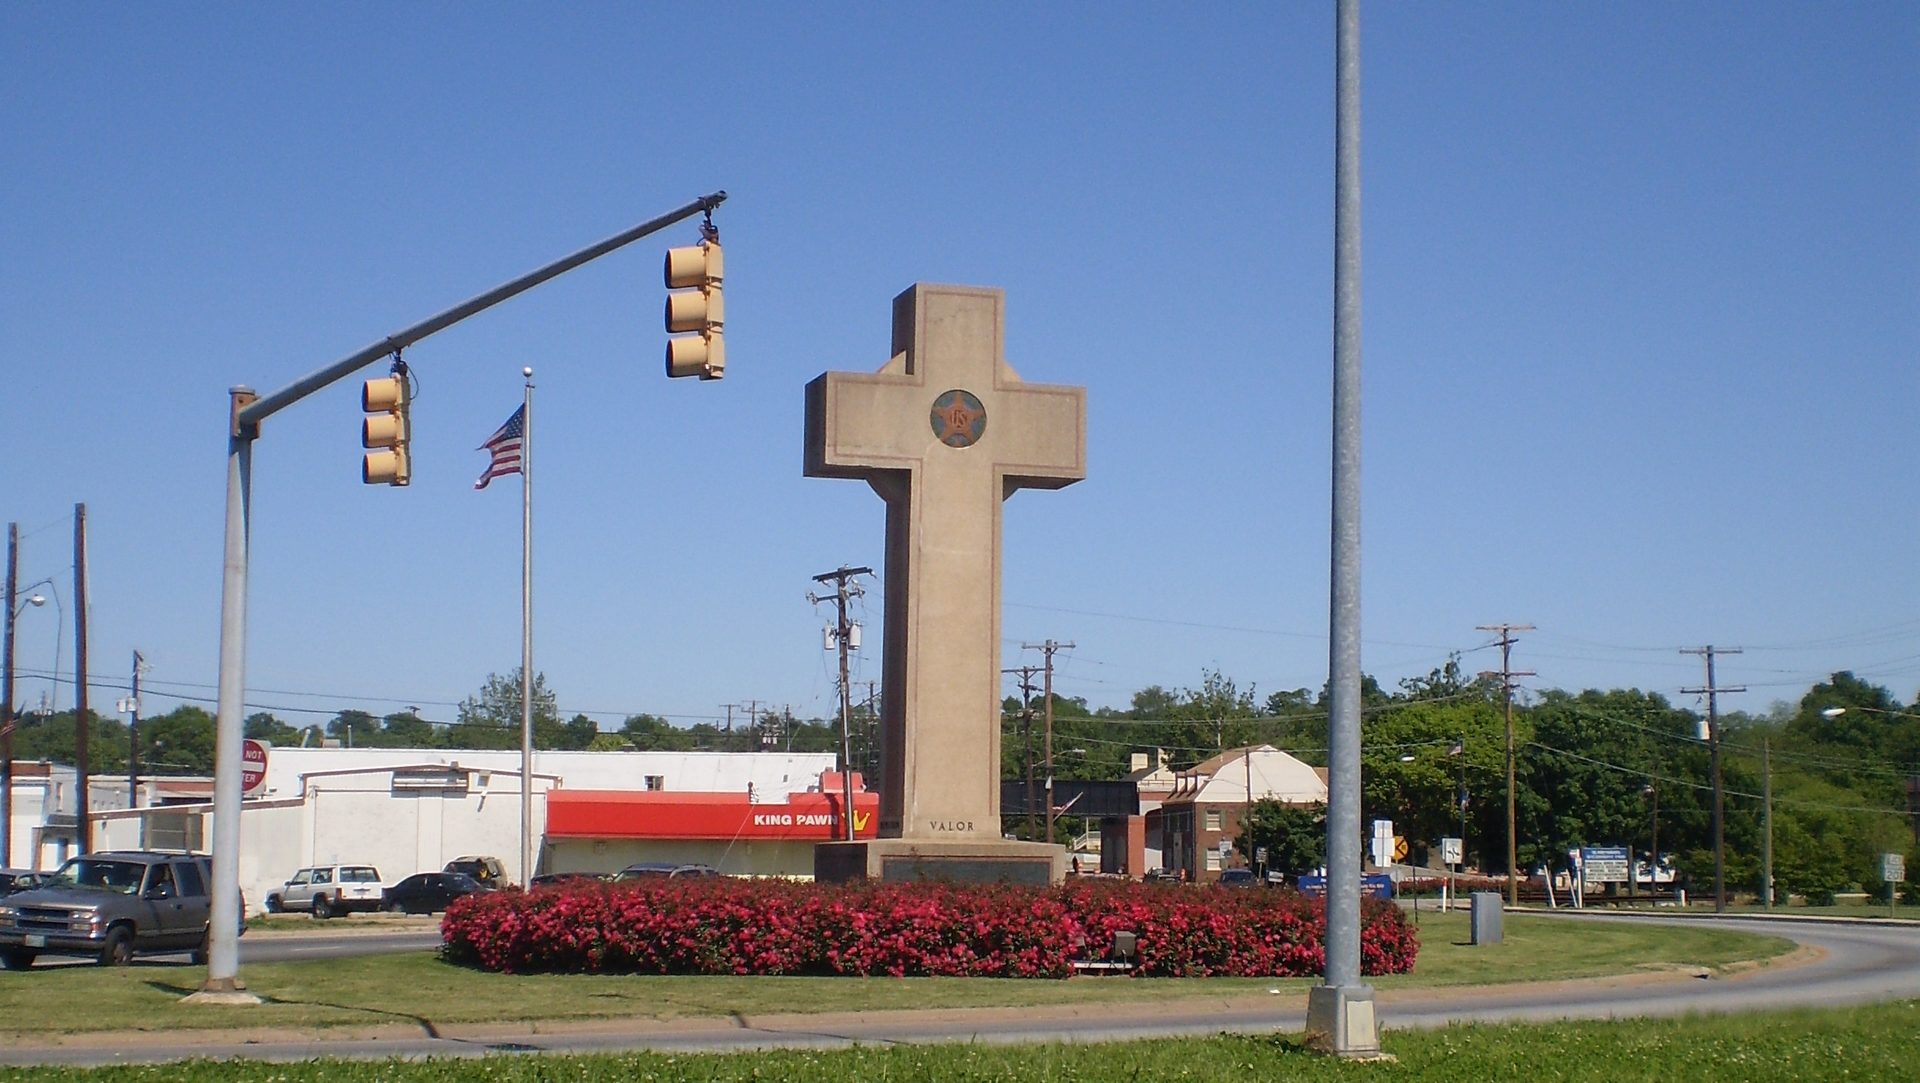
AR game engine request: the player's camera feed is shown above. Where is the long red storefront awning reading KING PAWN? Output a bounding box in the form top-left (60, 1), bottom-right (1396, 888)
top-left (547, 789), bottom-right (879, 841)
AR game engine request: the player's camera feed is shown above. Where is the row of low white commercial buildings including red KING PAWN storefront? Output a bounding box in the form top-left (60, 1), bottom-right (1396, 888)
top-left (13, 747), bottom-right (856, 910)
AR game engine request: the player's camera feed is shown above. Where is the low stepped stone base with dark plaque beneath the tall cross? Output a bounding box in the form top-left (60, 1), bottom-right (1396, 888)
top-left (814, 839), bottom-right (1068, 887)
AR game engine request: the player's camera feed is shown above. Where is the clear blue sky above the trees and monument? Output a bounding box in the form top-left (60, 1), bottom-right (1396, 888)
top-left (0, 4), bottom-right (1920, 726)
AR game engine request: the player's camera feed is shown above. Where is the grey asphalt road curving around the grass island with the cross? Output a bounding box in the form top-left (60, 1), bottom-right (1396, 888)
top-left (0, 914), bottom-right (1920, 1064)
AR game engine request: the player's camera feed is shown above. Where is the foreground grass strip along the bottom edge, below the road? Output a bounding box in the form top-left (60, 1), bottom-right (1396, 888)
top-left (0, 1002), bottom-right (1920, 1083)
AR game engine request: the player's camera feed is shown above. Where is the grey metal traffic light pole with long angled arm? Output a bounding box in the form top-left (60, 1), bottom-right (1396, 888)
top-left (188, 192), bottom-right (726, 1002)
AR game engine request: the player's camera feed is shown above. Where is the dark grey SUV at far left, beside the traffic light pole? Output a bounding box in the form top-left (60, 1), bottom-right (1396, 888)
top-left (0, 851), bottom-right (246, 970)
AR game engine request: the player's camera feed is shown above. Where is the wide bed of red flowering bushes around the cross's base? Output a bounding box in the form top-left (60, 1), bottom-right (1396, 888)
top-left (440, 878), bottom-right (1419, 977)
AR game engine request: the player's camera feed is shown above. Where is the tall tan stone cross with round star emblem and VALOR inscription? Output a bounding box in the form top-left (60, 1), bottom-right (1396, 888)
top-left (806, 284), bottom-right (1087, 881)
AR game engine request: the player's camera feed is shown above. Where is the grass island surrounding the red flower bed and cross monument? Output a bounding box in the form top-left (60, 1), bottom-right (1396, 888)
top-left (0, 914), bottom-right (1793, 1045)
